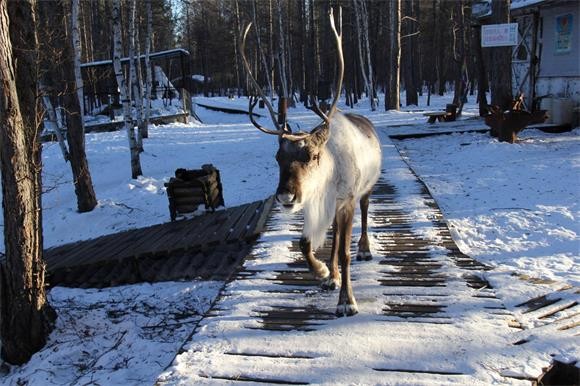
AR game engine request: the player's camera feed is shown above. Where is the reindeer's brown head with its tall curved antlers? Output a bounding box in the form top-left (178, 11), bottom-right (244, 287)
top-left (240, 9), bottom-right (344, 211)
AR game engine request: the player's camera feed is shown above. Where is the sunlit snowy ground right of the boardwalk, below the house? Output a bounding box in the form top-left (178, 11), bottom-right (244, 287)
top-left (399, 129), bottom-right (580, 305)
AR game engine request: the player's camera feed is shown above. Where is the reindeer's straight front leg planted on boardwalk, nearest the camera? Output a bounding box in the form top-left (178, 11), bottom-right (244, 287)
top-left (336, 202), bottom-right (358, 316)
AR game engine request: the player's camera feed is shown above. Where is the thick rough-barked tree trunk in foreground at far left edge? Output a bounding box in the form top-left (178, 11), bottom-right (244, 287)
top-left (0, 0), bottom-right (56, 364)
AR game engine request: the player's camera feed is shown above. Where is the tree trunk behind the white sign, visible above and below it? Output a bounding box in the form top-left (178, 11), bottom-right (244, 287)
top-left (489, 0), bottom-right (513, 111)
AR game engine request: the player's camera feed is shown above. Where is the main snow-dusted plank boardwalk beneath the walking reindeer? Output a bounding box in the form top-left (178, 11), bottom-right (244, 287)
top-left (158, 142), bottom-right (547, 385)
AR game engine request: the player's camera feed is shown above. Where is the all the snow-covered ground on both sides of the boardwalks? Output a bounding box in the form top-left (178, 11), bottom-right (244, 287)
top-left (0, 92), bottom-right (580, 385)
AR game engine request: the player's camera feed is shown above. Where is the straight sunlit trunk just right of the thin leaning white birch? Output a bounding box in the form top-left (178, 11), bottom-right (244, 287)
top-left (385, 0), bottom-right (401, 110)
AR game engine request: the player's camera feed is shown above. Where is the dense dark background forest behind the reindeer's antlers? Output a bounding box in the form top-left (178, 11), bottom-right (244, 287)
top-left (52, 0), bottom-right (508, 109)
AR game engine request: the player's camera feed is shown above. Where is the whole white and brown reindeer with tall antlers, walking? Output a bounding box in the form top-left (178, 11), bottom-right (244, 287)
top-left (240, 10), bottom-right (382, 316)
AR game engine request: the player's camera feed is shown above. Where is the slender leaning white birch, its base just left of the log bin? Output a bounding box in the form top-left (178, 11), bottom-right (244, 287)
top-left (112, 0), bottom-right (143, 178)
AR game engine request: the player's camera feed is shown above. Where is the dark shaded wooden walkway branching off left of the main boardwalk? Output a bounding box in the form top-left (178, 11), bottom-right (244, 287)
top-left (44, 198), bottom-right (273, 288)
